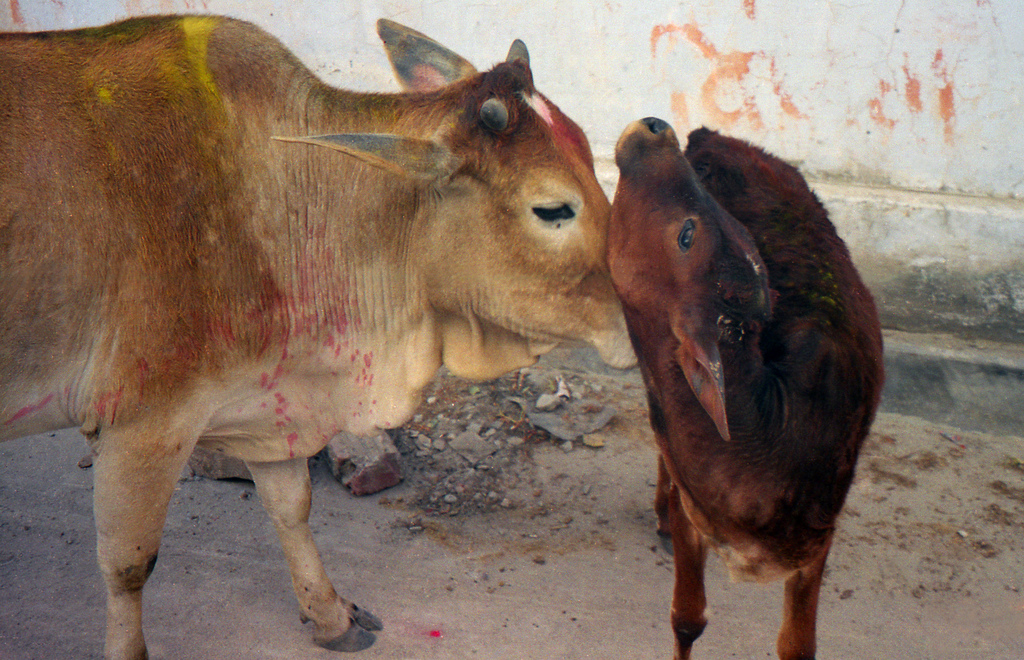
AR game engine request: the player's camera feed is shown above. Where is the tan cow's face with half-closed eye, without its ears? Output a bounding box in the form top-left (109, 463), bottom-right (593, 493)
top-left (419, 60), bottom-right (633, 376)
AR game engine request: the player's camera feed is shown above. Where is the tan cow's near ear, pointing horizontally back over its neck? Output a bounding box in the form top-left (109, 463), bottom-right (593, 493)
top-left (273, 133), bottom-right (459, 180)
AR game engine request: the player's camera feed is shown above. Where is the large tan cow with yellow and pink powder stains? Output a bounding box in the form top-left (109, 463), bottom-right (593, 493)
top-left (0, 16), bottom-right (633, 658)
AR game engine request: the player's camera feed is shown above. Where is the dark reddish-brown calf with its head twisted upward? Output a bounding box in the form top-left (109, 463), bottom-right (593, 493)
top-left (608, 119), bottom-right (884, 660)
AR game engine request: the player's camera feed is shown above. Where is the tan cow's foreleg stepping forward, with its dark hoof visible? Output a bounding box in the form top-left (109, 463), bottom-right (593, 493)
top-left (248, 457), bottom-right (383, 651)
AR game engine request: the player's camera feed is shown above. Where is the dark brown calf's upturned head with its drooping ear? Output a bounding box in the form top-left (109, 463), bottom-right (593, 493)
top-left (608, 118), bottom-right (771, 439)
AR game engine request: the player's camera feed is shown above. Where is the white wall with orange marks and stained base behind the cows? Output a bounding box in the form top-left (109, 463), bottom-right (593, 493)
top-left (0, 0), bottom-right (1024, 341)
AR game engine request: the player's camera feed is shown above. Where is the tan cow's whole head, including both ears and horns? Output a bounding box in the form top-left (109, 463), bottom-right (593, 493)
top-left (280, 20), bottom-right (635, 378)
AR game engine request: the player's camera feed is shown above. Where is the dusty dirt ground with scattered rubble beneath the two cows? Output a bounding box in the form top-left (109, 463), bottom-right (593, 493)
top-left (0, 350), bottom-right (1024, 660)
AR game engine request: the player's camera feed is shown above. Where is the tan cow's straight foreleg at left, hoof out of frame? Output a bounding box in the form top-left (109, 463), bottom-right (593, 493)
top-left (93, 430), bottom-right (190, 660)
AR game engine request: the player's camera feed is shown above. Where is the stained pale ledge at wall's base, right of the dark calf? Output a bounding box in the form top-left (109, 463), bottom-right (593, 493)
top-left (810, 181), bottom-right (1024, 342)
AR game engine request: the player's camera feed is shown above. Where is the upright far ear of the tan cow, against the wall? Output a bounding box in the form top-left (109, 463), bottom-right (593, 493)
top-left (377, 18), bottom-right (476, 92)
